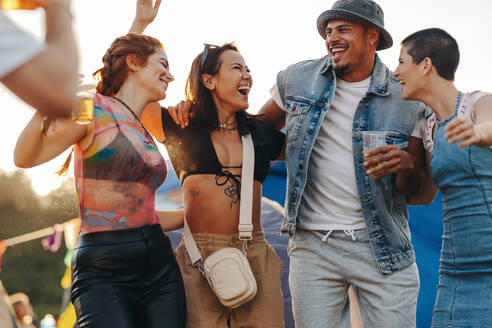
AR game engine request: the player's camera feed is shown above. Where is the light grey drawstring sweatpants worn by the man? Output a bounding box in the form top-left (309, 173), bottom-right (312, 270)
top-left (288, 229), bottom-right (419, 328)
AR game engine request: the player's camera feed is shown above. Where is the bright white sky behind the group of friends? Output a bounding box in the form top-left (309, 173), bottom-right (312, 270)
top-left (0, 0), bottom-right (492, 194)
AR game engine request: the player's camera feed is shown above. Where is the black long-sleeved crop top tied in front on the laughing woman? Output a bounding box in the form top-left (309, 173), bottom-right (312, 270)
top-left (161, 108), bottom-right (285, 184)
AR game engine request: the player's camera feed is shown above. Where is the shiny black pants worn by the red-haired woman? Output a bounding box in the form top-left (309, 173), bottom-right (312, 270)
top-left (72, 225), bottom-right (186, 328)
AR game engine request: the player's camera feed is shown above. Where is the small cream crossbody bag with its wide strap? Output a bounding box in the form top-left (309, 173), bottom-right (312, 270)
top-left (183, 134), bottom-right (256, 309)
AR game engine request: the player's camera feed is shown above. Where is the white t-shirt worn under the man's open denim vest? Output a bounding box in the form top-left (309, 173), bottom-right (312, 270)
top-left (270, 77), bottom-right (420, 231)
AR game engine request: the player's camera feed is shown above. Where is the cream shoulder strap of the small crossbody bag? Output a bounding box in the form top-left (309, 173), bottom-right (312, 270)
top-left (183, 134), bottom-right (255, 266)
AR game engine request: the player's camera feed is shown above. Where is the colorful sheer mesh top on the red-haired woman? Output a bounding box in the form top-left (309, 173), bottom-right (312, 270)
top-left (75, 94), bottom-right (167, 233)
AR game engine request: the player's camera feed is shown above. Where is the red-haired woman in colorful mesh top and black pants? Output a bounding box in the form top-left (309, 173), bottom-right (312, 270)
top-left (14, 34), bottom-right (186, 328)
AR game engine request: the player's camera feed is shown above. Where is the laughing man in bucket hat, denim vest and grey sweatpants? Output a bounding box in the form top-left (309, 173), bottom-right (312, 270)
top-left (260, 0), bottom-right (428, 328)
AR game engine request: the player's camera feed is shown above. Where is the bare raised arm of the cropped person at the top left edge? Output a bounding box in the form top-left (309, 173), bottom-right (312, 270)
top-left (1, 0), bottom-right (79, 117)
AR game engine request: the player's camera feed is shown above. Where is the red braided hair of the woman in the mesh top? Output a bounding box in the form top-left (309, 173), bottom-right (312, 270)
top-left (93, 33), bottom-right (164, 96)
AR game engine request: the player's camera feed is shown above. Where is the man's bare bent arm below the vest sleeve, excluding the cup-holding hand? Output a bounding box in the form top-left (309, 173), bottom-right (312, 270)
top-left (396, 137), bottom-right (438, 205)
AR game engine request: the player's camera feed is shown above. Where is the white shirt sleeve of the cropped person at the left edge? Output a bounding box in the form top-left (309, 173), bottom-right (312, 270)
top-left (0, 10), bottom-right (44, 78)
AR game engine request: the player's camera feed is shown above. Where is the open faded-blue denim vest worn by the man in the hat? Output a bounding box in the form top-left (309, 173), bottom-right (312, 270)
top-left (277, 55), bottom-right (420, 275)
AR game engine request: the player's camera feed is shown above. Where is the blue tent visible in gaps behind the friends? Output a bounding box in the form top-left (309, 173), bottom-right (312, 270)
top-left (156, 162), bottom-right (442, 328)
